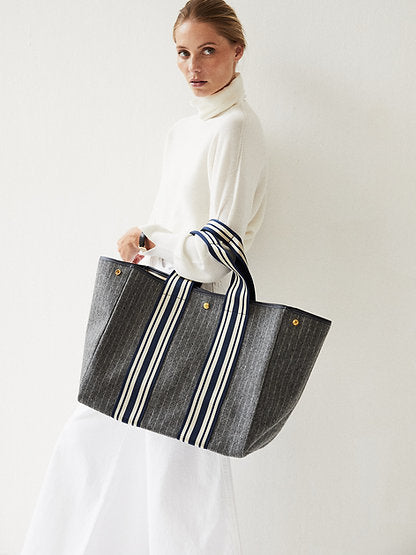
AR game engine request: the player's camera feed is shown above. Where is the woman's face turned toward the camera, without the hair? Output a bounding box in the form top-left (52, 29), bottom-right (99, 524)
top-left (175, 19), bottom-right (244, 96)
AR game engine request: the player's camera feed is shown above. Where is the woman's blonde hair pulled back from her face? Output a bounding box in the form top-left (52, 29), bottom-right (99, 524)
top-left (173, 0), bottom-right (246, 48)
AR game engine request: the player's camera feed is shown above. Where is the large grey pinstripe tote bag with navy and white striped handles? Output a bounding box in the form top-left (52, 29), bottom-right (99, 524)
top-left (78, 219), bottom-right (331, 457)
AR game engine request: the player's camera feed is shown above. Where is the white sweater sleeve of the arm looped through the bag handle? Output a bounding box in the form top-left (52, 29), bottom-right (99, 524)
top-left (139, 112), bottom-right (266, 283)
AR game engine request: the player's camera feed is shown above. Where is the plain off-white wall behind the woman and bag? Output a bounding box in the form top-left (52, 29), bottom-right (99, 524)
top-left (0, 0), bottom-right (416, 555)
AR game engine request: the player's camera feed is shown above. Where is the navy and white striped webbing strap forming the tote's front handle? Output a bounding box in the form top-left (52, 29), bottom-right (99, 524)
top-left (113, 219), bottom-right (255, 448)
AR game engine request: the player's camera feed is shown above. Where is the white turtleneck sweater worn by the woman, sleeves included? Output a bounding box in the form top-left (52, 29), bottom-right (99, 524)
top-left (139, 74), bottom-right (266, 283)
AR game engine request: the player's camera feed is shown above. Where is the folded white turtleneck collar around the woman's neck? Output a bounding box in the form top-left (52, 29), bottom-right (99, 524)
top-left (190, 73), bottom-right (245, 120)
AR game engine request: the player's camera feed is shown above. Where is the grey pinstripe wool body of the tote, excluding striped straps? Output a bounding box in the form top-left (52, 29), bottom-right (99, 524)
top-left (78, 228), bottom-right (331, 457)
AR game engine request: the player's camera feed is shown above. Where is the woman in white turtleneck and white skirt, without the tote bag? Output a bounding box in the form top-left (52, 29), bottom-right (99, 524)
top-left (23, 0), bottom-right (266, 555)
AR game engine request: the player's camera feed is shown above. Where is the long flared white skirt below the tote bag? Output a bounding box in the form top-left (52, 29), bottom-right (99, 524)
top-left (22, 263), bottom-right (241, 555)
